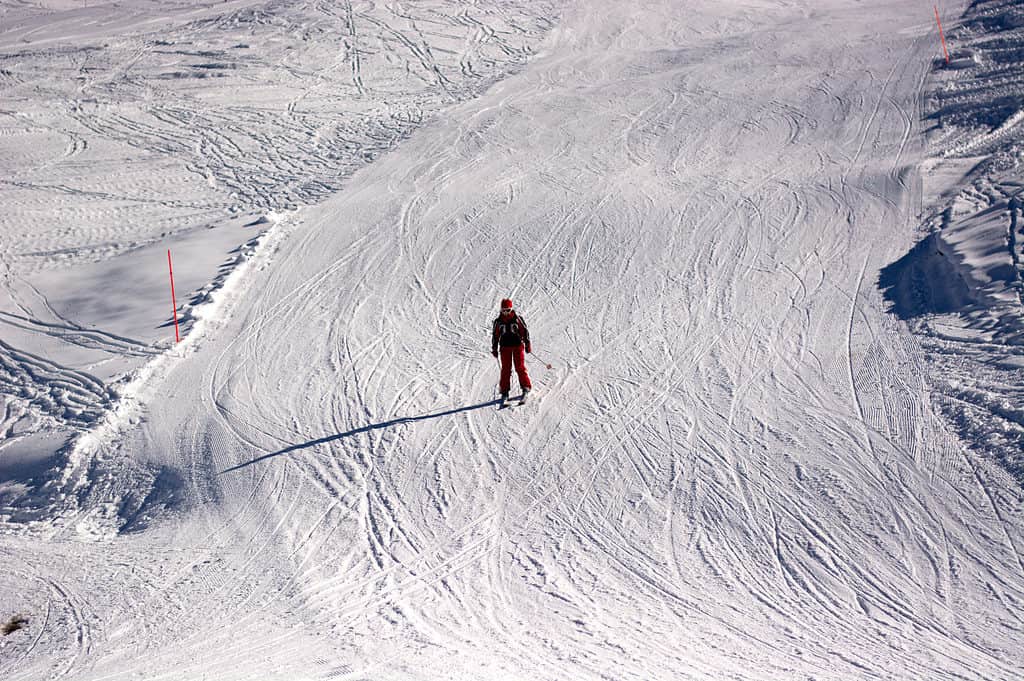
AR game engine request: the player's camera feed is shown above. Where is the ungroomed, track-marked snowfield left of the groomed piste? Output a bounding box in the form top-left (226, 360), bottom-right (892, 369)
top-left (0, 0), bottom-right (557, 485)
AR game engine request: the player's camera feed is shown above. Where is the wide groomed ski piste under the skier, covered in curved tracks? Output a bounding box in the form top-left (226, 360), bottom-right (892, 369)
top-left (0, 0), bottom-right (1024, 679)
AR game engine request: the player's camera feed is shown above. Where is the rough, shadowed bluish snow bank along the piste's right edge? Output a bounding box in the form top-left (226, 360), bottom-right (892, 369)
top-left (883, 0), bottom-right (1024, 477)
